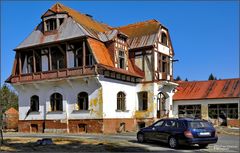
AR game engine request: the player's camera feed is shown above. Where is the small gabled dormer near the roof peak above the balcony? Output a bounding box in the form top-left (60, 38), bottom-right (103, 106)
top-left (41, 3), bottom-right (68, 33)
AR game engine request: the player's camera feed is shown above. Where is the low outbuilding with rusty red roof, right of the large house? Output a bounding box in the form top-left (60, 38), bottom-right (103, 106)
top-left (173, 78), bottom-right (240, 127)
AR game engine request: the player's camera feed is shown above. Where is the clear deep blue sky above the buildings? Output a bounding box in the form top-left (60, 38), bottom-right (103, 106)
top-left (1, 1), bottom-right (239, 84)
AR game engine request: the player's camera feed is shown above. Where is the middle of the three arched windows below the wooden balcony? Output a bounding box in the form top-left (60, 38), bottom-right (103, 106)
top-left (50, 93), bottom-right (63, 111)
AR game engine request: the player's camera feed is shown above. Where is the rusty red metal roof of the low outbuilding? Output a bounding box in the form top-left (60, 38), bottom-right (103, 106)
top-left (173, 78), bottom-right (240, 101)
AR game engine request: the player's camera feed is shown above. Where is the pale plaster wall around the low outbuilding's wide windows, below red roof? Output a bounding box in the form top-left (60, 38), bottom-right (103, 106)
top-left (173, 98), bottom-right (240, 120)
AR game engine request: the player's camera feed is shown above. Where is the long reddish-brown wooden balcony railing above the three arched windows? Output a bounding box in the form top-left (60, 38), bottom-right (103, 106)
top-left (7, 65), bottom-right (97, 83)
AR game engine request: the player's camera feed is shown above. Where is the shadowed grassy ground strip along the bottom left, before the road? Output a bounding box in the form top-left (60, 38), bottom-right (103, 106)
top-left (1, 139), bottom-right (152, 152)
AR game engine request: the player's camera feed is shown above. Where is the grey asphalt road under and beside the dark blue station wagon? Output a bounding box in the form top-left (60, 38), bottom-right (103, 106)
top-left (4, 133), bottom-right (240, 152)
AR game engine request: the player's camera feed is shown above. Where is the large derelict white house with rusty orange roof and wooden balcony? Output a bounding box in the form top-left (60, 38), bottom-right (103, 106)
top-left (7, 3), bottom-right (177, 133)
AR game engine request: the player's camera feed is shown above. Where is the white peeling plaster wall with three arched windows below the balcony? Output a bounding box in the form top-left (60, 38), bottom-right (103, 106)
top-left (14, 78), bottom-right (102, 122)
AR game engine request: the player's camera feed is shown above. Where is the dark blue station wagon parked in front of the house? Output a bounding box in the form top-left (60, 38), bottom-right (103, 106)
top-left (137, 118), bottom-right (218, 148)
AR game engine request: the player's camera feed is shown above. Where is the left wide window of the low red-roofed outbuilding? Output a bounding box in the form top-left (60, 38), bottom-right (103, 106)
top-left (178, 105), bottom-right (201, 118)
